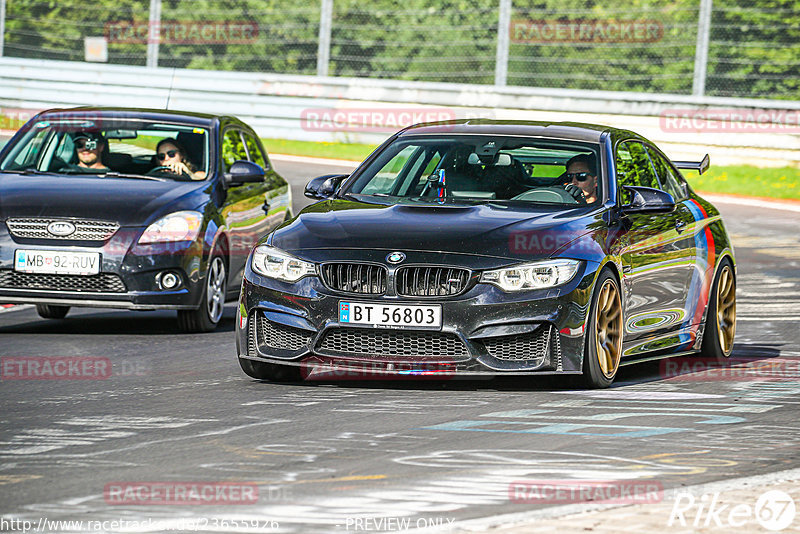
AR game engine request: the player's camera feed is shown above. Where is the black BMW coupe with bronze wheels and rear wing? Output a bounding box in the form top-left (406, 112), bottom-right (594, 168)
top-left (236, 120), bottom-right (736, 387)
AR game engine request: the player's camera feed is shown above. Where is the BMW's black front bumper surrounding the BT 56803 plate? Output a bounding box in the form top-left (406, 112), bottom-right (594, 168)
top-left (236, 262), bottom-right (597, 377)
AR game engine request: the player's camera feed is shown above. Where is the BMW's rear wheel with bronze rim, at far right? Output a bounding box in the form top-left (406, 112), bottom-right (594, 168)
top-left (700, 260), bottom-right (736, 362)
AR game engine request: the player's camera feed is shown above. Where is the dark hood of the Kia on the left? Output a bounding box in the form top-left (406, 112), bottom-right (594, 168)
top-left (0, 174), bottom-right (209, 226)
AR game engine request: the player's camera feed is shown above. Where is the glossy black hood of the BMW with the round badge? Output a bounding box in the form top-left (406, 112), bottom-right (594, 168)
top-left (270, 200), bottom-right (597, 261)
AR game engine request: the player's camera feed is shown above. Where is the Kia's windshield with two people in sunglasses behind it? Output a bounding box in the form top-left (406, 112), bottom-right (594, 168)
top-left (0, 117), bottom-right (209, 180)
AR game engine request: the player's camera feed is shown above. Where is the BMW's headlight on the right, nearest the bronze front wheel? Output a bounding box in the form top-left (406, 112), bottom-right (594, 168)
top-left (481, 260), bottom-right (581, 291)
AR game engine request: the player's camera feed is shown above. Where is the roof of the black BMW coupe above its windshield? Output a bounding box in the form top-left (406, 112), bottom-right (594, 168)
top-left (400, 119), bottom-right (615, 143)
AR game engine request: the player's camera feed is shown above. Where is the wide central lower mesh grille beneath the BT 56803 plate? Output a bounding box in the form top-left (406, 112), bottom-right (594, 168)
top-left (316, 328), bottom-right (469, 359)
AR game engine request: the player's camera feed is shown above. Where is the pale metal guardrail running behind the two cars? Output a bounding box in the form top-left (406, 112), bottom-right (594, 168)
top-left (0, 58), bottom-right (800, 165)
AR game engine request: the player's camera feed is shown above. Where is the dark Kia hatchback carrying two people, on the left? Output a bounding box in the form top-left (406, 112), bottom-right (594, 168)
top-left (0, 108), bottom-right (291, 332)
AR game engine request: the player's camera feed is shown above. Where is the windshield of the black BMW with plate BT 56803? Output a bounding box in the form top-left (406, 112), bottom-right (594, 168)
top-left (345, 135), bottom-right (601, 205)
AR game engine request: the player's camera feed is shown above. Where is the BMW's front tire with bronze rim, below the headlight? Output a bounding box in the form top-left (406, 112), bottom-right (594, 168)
top-left (582, 270), bottom-right (623, 389)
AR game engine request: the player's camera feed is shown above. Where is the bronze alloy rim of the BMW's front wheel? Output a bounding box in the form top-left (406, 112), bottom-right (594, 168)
top-left (595, 279), bottom-right (622, 379)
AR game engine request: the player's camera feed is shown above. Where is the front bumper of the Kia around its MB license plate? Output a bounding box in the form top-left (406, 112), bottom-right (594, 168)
top-left (0, 228), bottom-right (205, 310)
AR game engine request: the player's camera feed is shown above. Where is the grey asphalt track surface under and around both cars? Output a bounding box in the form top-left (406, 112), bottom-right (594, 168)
top-left (0, 157), bottom-right (800, 533)
